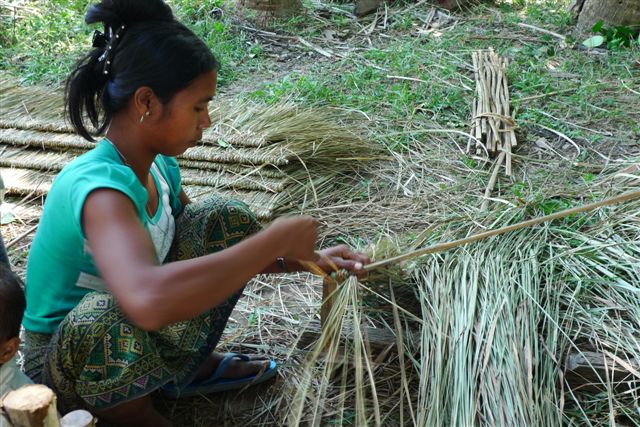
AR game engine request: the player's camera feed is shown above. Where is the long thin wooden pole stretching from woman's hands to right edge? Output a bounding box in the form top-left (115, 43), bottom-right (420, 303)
top-left (363, 191), bottom-right (640, 271)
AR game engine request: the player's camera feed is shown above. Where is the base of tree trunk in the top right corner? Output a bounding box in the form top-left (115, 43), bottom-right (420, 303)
top-left (570, 0), bottom-right (640, 34)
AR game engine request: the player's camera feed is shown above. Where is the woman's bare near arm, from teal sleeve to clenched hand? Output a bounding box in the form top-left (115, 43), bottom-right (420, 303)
top-left (82, 189), bottom-right (317, 330)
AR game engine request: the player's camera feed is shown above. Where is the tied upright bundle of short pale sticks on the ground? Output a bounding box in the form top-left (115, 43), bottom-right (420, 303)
top-left (467, 48), bottom-right (517, 176)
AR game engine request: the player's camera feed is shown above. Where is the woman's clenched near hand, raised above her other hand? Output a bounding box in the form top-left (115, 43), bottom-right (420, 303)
top-left (268, 216), bottom-right (318, 261)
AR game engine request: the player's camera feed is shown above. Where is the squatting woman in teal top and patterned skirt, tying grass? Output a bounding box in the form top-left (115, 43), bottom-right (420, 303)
top-left (24, 0), bottom-right (369, 426)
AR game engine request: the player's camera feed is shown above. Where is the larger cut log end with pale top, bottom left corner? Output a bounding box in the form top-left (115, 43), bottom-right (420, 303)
top-left (2, 384), bottom-right (60, 427)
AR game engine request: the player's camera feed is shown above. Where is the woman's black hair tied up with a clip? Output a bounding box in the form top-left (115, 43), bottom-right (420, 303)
top-left (65, 0), bottom-right (220, 141)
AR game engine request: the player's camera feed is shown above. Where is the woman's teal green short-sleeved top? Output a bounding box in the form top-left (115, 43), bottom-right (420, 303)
top-left (23, 139), bottom-right (182, 334)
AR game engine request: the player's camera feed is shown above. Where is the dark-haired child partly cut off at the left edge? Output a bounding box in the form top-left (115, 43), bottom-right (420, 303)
top-left (0, 263), bottom-right (31, 426)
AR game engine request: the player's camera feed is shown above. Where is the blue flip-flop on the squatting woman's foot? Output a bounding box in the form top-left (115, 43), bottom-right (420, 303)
top-left (161, 353), bottom-right (277, 398)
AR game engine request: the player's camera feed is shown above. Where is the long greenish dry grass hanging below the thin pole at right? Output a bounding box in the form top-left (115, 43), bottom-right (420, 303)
top-left (276, 163), bottom-right (640, 426)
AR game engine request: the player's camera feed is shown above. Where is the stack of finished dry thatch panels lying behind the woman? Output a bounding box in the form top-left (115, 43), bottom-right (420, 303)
top-left (0, 74), bottom-right (377, 220)
